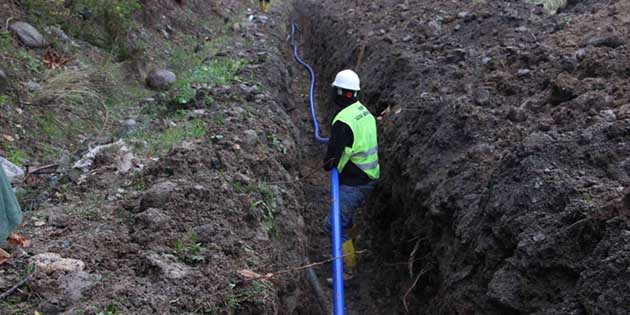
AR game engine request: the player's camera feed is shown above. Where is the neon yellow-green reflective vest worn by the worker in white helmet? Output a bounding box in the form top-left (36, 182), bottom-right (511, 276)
top-left (333, 102), bottom-right (380, 180)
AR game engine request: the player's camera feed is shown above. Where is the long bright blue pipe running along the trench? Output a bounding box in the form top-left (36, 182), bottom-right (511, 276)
top-left (291, 24), bottom-right (345, 315)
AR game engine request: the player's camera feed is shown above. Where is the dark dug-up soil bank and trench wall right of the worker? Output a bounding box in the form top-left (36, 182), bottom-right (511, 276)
top-left (297, 0), bottom-right (630, 315)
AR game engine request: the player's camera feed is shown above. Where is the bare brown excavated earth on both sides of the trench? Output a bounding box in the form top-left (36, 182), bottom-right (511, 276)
top-left (0, 0), bottom-right (630, 314)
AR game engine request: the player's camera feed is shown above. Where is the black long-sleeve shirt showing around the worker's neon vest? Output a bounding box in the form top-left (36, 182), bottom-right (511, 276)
top-left (324, 121), bottom-right (371, 186)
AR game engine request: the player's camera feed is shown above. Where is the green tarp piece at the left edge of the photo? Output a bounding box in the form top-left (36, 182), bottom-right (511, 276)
top-left (0, 166), bottom-right (22, 244)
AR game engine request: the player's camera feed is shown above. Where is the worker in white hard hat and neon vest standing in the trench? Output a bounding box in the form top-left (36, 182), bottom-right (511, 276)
top-left (324, 70), bottom-right (380, 279)
